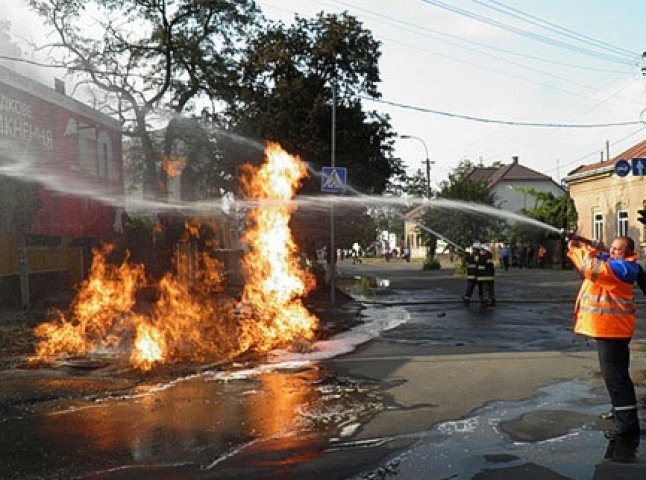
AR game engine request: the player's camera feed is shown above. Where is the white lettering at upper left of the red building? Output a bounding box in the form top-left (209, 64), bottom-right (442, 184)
top-left (0, 95), bottom-right (54, 150)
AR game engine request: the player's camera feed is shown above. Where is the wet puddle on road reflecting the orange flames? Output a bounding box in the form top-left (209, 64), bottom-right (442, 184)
top-left (0, 364), bottom-right (382, 479)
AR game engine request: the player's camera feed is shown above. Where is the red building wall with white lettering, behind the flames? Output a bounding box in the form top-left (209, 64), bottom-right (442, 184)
top-left (0, 67), bottom-right (124, 305)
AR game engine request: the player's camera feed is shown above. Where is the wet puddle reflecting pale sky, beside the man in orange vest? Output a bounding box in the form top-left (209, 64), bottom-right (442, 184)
top-left (354, 381), bottom-right (646, 480)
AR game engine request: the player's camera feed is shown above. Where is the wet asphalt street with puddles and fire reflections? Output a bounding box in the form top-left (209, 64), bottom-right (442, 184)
top-left (0, 260), bottom-right (646, 479)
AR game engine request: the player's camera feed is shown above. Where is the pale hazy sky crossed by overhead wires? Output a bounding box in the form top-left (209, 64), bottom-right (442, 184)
top-left (0, 0), bottom-right (646, 187)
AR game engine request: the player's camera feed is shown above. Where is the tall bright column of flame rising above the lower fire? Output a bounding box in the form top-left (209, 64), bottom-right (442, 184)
top-left (241, 143), bottom-right (318, 352)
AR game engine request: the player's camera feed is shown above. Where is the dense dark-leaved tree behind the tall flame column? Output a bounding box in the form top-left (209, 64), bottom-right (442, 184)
top-left (225, 13), bottom-right (403, 251)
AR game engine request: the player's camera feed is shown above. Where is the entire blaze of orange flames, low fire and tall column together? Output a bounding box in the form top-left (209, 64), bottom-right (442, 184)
top-left (29, 143), bottom-right (318, 371)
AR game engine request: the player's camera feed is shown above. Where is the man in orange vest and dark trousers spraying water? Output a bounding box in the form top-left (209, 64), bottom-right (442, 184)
top-left (567, 237), bottom-right (646, 438)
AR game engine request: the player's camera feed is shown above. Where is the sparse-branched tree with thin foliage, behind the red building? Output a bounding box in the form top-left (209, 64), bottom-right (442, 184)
top-left (30, 0), bottom-right (258, 196)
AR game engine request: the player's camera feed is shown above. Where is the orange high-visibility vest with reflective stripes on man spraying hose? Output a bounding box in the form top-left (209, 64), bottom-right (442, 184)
top-left (568, 247), bottom-right (638, 338)
